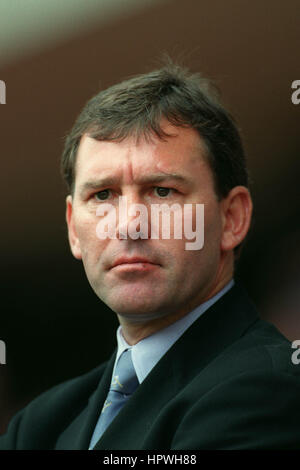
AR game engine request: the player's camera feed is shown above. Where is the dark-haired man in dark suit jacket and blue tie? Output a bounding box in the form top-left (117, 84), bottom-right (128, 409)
top-left (0, 60), bottom-right (300, 450)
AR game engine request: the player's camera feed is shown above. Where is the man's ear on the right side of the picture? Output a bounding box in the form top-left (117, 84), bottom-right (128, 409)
top-left (221, 186), bottom-right (253, 251)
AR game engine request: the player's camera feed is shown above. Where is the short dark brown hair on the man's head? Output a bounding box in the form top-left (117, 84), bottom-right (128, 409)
top-left (61, 60), bottom-right (248, 199)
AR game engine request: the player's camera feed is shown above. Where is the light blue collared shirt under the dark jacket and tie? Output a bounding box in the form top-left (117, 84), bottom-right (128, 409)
top-left (90, 280), bottom-right (234, 449)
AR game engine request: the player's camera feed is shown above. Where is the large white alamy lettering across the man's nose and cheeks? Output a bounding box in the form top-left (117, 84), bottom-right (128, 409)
top-left (96, 196), bottom-right (204, 250)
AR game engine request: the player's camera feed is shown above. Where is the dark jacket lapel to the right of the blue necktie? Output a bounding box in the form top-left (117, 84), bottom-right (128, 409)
top-left (94, 286), bottom-right (258, 450)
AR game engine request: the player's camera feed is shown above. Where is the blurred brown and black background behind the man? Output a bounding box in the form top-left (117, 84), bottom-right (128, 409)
top-left (0, 0), bottom-right (300, 433)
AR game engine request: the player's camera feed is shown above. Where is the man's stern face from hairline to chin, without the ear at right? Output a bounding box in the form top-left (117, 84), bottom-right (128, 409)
top-left (67, 124), bottom-right (230, 321)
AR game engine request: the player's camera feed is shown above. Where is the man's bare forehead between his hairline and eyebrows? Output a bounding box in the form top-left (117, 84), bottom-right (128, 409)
top-left (75, 123), bottom-right (211, 186)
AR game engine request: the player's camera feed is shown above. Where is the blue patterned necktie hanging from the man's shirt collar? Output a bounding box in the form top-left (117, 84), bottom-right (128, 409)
top-left (90, 349), bottom-right (139, 448)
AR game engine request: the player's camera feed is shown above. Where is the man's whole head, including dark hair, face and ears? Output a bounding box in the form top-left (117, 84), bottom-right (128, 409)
top-left (62, 60), bottom-right (252, 336)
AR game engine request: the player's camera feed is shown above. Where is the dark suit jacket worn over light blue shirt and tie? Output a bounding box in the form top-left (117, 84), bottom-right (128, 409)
top-left (0, 286), bottom-right (300, 450)
